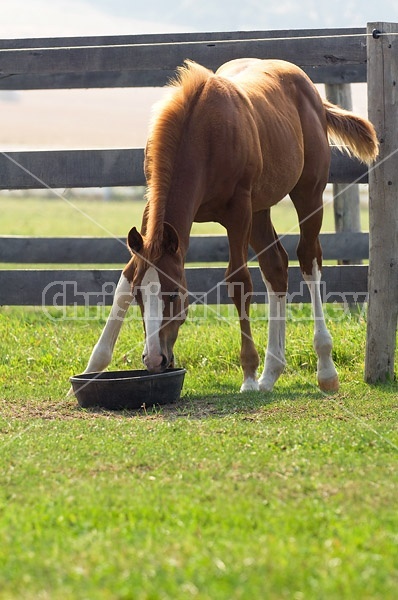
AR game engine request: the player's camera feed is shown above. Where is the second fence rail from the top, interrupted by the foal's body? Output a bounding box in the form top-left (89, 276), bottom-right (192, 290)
top-left (0, 148), bottom-right (367, 190)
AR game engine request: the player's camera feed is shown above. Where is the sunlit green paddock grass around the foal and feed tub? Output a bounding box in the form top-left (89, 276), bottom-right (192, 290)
top-left (0, 195), bottom-right (398, 600)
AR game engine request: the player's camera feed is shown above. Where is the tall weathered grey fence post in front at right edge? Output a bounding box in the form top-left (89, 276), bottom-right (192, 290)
top-left (365, 23), bottom-right (398, 383)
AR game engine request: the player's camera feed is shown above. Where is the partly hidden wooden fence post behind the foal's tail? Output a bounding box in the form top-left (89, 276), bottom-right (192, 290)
top-left (325, 83), bottom-right (361, 265)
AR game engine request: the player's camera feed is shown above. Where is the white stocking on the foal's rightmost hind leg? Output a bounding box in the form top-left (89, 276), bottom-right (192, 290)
top-left (303, 258), bottom-right (338, 391)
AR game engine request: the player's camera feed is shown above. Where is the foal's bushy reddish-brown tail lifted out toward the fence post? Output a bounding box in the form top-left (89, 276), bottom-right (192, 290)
top-left (323, 100), bottom-right (379, 164)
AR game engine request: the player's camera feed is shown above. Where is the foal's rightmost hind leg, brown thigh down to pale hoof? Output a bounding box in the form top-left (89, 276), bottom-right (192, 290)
top-left (290, 190), bottom-right (339, 392)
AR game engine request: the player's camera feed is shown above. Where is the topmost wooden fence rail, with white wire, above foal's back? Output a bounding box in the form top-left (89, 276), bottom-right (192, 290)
top-left (0, 28), bottom-right (366, 90)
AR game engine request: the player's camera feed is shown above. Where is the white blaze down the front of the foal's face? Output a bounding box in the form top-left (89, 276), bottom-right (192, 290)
top-left (140, 267), bottom-right (164, 368)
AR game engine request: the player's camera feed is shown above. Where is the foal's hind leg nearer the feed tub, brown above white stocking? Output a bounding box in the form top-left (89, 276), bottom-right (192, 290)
top-left (250, 210), bottom-right (288, 392)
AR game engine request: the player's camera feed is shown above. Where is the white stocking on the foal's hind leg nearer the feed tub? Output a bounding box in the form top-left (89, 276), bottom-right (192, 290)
top-left (258, 279), bottom-right (286, 392)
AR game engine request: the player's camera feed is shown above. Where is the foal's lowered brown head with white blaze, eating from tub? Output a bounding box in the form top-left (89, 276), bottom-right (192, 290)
top-left (128, 223), bottom-right (188, 373)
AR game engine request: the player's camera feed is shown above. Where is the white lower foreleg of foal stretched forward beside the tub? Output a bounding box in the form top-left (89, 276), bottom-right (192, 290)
top-left (84, 273), bottom-right (133, 373)
